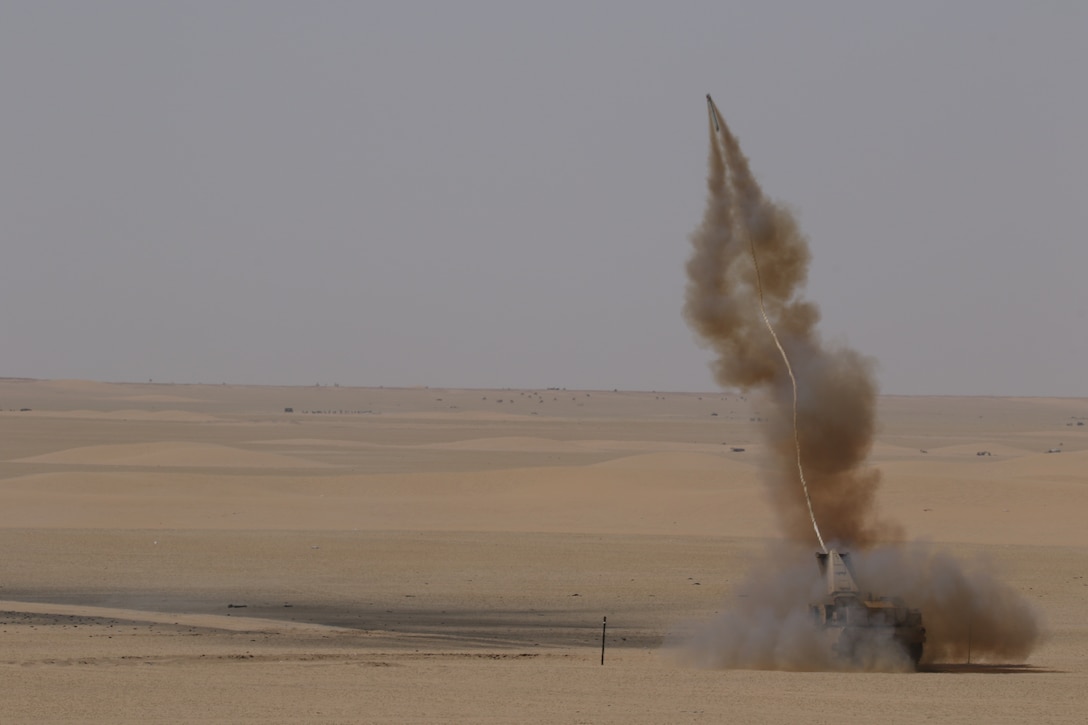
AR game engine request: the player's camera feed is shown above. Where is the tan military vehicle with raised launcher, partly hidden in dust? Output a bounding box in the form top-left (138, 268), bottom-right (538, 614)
top-left (809, 549), bottom-right (926, 666)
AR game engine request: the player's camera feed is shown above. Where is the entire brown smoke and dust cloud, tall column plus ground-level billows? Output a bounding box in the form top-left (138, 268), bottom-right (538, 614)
top-left (680, 96), bottom-right (1040, 671)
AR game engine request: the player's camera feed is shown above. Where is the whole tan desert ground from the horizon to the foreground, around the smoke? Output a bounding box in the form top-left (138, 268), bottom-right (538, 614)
top-left (0, 380), bottom-right (1088, 723)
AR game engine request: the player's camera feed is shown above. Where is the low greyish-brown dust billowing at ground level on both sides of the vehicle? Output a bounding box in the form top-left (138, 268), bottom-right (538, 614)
top-left (669, 543), bottom-right (1042, 672)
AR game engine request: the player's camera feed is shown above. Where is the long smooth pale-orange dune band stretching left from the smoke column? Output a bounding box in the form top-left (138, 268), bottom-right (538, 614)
top-left (0, 454), bottom-right (771, 536)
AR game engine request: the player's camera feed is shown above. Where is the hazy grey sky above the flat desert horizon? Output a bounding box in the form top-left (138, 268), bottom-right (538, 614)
top-left (0, 0), bottom-right (1088, 396)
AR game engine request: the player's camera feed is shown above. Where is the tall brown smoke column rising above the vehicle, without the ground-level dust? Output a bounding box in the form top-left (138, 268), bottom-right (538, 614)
top-left (684, 97), bottom-right (901, 550)
